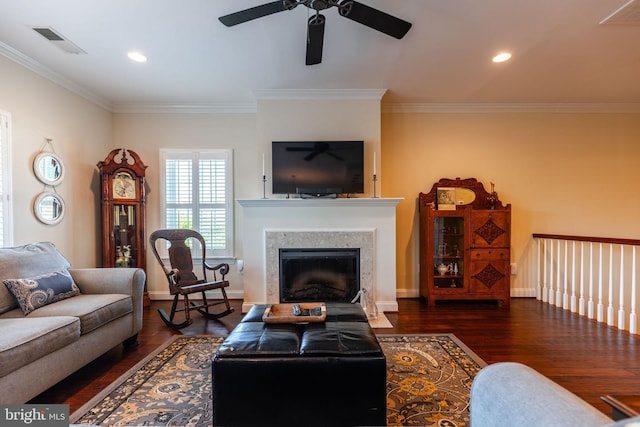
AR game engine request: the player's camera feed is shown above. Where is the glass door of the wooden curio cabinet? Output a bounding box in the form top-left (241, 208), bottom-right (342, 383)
top-left (433, 216), bottom-right (465, 288)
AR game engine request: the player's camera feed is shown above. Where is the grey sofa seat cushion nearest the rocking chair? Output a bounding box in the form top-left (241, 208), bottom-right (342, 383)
top-left (20, 294), bottom-right (133, 335)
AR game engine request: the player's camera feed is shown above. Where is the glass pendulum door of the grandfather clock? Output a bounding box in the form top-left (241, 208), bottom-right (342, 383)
top-left (113, 205), bottom-right (138, 267)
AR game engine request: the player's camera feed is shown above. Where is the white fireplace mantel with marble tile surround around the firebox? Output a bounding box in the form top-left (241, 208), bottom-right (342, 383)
top-left (238, 198), bottom-right (402, 312)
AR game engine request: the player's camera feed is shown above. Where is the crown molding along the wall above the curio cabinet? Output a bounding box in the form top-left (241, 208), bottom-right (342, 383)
top-left (382, 103), bottom-right (640, 114)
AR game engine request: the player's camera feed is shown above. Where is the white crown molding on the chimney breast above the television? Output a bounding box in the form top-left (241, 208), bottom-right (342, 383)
top-left (253, 89), bottom-right (387, 101)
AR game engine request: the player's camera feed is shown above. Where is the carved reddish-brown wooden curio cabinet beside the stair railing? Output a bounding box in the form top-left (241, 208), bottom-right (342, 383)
top-left (419, 178), bottom-right (511, 306)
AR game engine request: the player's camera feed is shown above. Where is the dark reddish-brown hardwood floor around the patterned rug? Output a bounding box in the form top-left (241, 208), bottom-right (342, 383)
top-left (32, 298), bottom-right (640, 415)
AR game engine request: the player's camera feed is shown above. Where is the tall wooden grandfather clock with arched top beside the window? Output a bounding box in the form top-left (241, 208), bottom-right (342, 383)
top-left (98, 148), bottom-right (148, 302)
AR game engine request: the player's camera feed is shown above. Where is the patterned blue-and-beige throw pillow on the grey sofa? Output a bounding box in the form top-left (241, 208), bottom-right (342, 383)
top-left (4, 270), bottom-right (80, 315)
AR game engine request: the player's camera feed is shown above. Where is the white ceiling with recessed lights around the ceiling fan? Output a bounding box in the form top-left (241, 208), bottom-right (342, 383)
top-left (0, 0), bottom-right (640, 111)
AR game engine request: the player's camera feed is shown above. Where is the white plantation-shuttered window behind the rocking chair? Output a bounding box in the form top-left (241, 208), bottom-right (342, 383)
top-left (160, 150), bottom-right (233, 258)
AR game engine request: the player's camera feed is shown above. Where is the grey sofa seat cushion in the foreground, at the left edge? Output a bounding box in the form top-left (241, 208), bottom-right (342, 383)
top-left (0, 316), bottom-right (80, 377)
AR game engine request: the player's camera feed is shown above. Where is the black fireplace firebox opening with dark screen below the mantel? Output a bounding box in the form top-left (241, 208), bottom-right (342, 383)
top-left (280, 249), bottom-right (360, 302)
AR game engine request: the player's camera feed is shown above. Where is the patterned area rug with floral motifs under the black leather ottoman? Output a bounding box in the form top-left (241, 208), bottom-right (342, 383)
top-left (71, 334), bottom-right (486, 427)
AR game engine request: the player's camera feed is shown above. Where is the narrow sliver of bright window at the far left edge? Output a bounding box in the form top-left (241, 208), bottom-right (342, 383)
top-left (0, 111), bottom-right (13, 247)
